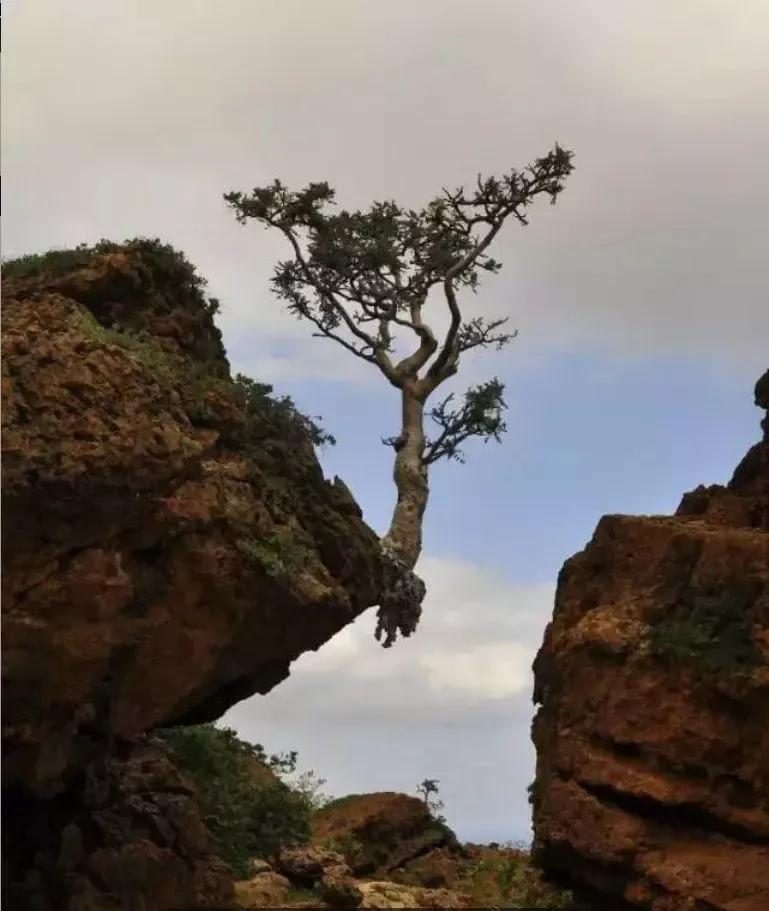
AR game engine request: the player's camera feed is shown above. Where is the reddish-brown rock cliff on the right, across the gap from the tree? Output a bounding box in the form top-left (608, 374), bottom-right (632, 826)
top-left (532, 372), bottom-right (769, 911)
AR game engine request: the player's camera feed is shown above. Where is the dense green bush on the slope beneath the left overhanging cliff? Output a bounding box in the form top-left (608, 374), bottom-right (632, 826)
top-left (158, 724), bottom-right (312, 878)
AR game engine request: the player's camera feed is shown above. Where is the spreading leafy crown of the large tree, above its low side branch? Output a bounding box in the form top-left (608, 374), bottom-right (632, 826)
top-left (225, 145), bottom-right (572, 399)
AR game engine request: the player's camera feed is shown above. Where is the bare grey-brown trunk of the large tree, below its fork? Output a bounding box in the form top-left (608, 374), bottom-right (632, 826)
top-left (384, 384), bottom-right (429, 569)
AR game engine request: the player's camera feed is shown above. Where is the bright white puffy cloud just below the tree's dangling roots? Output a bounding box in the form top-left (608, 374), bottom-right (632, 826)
top-left (276, 557), bottom-right (554, 721)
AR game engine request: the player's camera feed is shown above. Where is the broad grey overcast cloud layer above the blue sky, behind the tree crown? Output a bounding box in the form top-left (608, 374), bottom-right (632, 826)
top-left (3, 0), bottom-right (769, 381)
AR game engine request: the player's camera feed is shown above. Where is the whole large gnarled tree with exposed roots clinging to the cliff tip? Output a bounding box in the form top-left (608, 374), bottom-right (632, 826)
top-left (224, 145), bottom-right (572, 647)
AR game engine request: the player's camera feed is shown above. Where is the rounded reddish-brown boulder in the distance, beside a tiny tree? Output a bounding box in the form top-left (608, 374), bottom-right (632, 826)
top-left (312, 792), bottom-right (459, 877)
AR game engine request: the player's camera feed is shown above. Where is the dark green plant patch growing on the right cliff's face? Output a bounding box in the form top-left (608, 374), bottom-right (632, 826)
top-left (651, 589), bottom-right (757, 672)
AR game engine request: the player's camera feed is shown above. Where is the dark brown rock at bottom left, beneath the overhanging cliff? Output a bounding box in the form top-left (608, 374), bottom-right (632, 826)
top-left (3, 744), bottom-right (233, 911)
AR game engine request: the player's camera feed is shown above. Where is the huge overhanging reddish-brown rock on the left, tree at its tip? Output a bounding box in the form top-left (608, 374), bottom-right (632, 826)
top-left (2, 241), bottom-right (381, 909)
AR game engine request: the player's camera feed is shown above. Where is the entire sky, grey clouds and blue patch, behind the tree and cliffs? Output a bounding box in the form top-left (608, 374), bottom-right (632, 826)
top-left (2, 0), bottom-right (769, 841)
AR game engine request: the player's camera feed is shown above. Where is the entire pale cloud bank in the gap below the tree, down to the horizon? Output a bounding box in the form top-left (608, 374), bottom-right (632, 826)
top-left (224, 557), bottom-right (553, 840)
